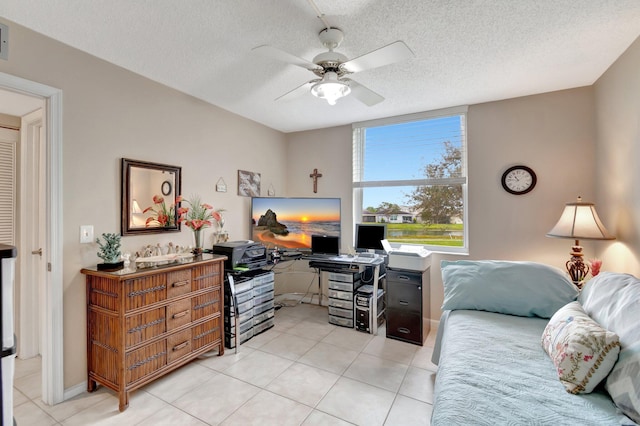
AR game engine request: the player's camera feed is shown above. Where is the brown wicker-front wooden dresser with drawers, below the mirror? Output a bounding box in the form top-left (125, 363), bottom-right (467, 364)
top-left (81, 254), bottom-right (226, 411)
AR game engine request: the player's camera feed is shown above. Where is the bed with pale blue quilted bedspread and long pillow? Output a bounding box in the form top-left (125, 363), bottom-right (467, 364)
top-left (431, 261), bottom-right (640, 426)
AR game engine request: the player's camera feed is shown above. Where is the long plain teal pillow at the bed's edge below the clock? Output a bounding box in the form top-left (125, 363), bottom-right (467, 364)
top-left (440, 260), bottom-right (578, 318)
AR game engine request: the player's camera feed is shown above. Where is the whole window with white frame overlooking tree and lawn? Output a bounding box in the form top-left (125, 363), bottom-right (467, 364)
top-left (353, 107), bottom-right (468, 252)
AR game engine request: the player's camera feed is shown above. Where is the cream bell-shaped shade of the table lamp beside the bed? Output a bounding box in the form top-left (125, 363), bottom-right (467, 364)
top-left (547, 197), bottom-right (616, 240)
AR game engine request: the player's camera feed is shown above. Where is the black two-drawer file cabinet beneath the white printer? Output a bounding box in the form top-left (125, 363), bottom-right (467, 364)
top-left (386, 268), bottom-right (431, 346)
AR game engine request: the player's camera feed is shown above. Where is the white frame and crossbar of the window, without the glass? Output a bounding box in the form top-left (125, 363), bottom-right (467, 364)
top-left (352, 105), bottom-right (469, 254)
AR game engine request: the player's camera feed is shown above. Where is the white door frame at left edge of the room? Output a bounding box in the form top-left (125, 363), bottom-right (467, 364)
top-left (0, 73), bottom-right (64, 405)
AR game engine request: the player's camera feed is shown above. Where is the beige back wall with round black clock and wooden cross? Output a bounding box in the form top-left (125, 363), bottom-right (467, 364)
top-left (288, 88), bottom-right (595, 320)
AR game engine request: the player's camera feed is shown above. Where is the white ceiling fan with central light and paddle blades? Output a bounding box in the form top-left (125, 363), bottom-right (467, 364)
top-left (253, 25), bottom-right (414, 106)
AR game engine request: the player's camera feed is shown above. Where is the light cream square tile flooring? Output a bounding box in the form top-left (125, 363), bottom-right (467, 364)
top-left (14, 304), bottom-right (436, 426)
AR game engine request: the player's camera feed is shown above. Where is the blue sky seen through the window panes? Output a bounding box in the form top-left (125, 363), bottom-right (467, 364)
top-left (363, 116), bottom-right (461, 208)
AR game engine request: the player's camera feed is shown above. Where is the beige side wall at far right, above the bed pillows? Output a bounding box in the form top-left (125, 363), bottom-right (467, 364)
top-left (594, 35), bottom-right (640, 275)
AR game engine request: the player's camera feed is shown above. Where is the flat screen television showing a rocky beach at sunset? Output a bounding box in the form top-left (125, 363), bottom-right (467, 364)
top-left (251, 197), bottom-right (340, 251)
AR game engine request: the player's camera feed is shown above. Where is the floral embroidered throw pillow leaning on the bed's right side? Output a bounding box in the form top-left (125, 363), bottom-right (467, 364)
top-left (542, 302), bottom-right (620, 394)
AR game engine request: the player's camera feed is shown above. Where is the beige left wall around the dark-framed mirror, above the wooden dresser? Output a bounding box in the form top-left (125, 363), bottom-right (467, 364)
top-left (0, 21), bottom-right (287, 388)
